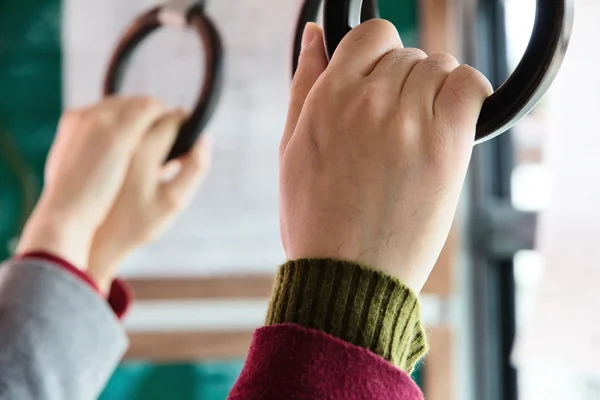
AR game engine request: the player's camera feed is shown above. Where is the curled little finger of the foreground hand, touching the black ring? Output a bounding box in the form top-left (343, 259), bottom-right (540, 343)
top-left (433, 65), bottom-right (493, 139)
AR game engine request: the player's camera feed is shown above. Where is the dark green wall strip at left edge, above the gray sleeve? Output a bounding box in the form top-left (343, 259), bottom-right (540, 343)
top-left (0, 0), bottom-right (62, 259)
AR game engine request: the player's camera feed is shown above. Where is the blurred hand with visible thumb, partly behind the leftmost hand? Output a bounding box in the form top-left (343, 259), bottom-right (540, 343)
top-left (88, 112), bottom-right (210, 291)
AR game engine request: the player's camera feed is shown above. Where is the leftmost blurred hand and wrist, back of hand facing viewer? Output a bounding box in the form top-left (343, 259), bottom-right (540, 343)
top-left (17, 97), bottom-right (165, 268)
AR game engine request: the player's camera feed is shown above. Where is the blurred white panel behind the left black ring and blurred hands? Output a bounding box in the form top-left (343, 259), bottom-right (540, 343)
top-left (63, 0), bottom-right (300, 276)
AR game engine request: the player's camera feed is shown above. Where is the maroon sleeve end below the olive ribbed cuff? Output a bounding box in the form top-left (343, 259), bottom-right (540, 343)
top-left (228, 324), bottom-right (423, 400)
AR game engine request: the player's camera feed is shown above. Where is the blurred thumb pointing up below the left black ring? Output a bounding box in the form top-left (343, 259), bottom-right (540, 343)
top-left (159, 136), bottom-right (212, 211)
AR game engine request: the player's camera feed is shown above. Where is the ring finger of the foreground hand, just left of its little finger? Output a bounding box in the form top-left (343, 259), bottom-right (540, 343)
top-left (402, 54), bottom-right (459, 117)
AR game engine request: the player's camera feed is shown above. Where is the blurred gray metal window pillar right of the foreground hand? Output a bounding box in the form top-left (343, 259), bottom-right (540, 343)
top-left (463, 0), bottom-right (536, 400)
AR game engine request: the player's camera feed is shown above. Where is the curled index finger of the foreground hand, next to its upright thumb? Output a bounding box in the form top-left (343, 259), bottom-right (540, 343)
top-left (330, 19), bottom-right (402, 78)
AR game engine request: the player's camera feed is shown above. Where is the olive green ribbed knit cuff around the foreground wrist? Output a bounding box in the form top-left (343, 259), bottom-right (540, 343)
top-left (266, 259), bottom-right (427, 372)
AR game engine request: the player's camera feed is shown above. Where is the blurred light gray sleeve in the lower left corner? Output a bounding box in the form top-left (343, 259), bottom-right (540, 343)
top-left (0, 260), bottom-right (128, 400)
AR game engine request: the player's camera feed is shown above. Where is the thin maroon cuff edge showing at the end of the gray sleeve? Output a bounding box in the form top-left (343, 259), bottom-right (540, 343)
top-left (15, 251), bottom-right (133, 319)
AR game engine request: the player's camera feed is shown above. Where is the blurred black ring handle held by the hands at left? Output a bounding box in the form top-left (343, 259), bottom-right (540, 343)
top-left (104, 5), bottom-right (223, 160)
